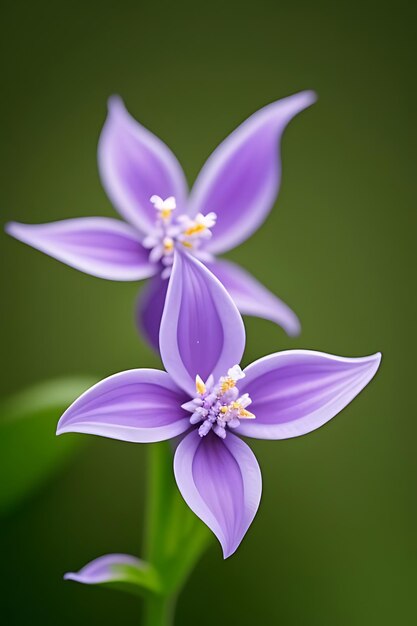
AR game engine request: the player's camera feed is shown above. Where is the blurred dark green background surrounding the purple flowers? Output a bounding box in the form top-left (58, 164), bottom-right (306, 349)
top-left (0, 0), bottom-right (417, 626)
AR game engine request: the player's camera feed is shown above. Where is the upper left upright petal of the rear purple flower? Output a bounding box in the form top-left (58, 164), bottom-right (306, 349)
top-left (98, 96), bottom-right (187, 234)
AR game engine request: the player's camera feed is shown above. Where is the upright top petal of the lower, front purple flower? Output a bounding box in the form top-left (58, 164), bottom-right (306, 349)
top-left (159, 252), bottom-right (245, 396)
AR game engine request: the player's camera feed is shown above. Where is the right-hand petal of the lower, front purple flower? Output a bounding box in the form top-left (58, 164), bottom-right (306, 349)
top-left (236, 350), bottom-right (381, 439)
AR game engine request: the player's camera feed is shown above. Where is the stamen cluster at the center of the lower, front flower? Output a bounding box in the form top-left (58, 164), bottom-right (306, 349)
top-left (182, 365), bottom-right (255, 439)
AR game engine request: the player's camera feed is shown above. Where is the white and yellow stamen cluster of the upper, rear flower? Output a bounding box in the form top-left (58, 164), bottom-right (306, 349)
top-left (143, 196), bottom-right (217, 278)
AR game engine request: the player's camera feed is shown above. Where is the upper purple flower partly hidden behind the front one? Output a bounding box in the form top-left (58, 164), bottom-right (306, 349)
top-left (6, 91), bottom-right (315, 348)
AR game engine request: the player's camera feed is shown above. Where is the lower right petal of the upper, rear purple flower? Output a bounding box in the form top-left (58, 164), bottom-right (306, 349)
top-left (206, 259), bottom-right (300, 337)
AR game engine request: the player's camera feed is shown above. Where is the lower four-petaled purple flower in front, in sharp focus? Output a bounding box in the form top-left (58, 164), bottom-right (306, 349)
top-left (57, 252), bottom-right (381, 558)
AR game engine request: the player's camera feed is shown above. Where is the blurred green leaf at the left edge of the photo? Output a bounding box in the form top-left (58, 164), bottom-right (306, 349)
top-left (0, 377), bottom-right (95, 515)
